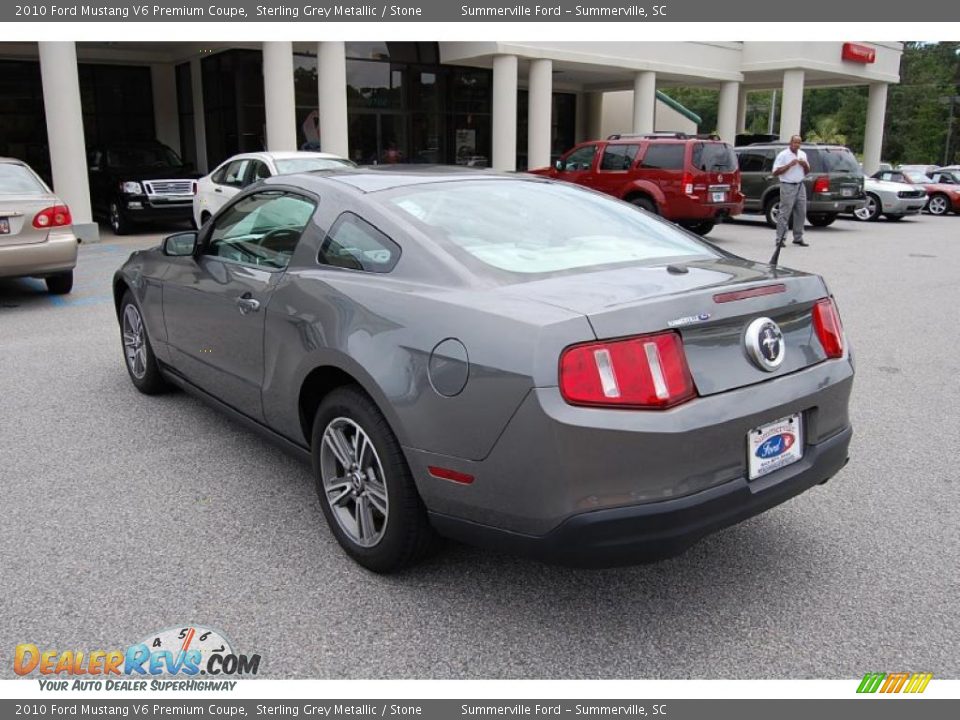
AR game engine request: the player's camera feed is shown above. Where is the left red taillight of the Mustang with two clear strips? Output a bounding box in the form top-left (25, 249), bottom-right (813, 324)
top-left (560, 332), bottom-right (697, 409)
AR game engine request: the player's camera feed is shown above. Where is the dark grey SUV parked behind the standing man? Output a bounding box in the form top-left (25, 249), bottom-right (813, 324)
top-left (734, 142), bottom-right (867, 227)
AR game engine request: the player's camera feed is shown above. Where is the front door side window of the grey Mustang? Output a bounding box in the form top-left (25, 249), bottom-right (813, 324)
top-left (203, 191), bottom-right (316, 270)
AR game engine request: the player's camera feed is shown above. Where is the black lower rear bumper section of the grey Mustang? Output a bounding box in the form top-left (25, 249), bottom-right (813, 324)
top-left (430, 426), bottom-right (853, 567)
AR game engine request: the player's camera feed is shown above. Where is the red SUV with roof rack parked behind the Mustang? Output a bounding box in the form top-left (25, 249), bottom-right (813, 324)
top-left (530, 133), bottom-right (743, 235)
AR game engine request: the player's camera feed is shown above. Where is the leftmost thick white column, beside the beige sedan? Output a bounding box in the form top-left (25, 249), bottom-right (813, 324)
top-left (39, 42), bottom-right (100, 242)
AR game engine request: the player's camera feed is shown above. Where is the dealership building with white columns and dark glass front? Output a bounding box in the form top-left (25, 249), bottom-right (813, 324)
top-left (0, 41), bottom-right (902, 240)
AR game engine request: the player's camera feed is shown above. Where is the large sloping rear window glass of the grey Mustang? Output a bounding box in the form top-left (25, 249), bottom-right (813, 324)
top-left (388, 180), bottom-right (715, 274)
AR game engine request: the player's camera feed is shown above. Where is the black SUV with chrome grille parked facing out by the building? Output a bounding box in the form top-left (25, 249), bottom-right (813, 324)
top-left (87, 142), bottom-right (198, 235)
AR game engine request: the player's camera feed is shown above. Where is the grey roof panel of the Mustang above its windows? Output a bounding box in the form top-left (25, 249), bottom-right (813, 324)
top-left (264, 165), bottom-right (524, 193)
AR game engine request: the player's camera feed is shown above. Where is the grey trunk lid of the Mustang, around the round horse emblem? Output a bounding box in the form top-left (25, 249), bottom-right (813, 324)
top-left (502, 258), bottom-right (827, 396)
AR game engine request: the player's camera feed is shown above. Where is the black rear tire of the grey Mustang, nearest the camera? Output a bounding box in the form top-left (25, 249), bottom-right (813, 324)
top-left (311, 386), bottom-right (437, 573)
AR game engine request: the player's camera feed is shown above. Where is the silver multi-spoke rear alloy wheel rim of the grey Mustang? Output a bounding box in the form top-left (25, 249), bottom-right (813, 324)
top-left (320, 417), bottom-right (390, 547)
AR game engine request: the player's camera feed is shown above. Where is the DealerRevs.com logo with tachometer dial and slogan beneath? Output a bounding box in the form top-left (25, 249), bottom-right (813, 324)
top-left (13, 625), bottom-right (261, 690)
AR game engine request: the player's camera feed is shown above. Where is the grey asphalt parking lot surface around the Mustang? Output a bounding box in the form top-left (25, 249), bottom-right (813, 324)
top-left (0, 216), bottom-right (960, 679)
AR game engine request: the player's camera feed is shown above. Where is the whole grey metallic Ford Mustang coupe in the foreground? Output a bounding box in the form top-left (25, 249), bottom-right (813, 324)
top-left (114, 168), bottom-right (854, 572)
